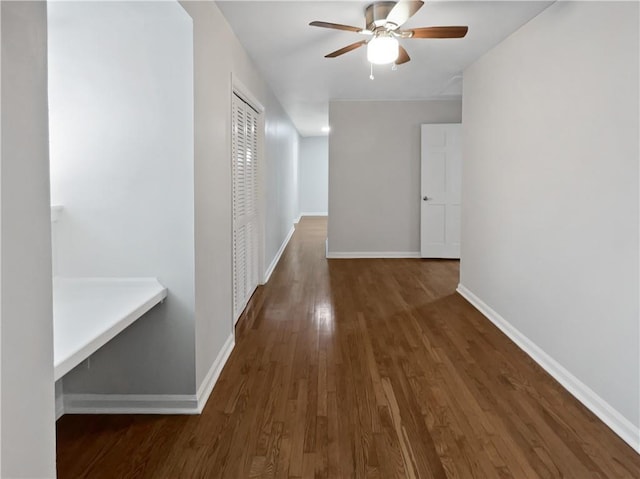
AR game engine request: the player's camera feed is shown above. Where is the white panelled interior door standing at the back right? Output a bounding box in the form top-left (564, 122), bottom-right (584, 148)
top-left (420, 123), bottom-right (462, 258)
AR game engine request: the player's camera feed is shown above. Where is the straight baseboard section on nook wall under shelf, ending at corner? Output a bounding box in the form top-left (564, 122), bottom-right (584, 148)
top-left (64, 394), bottom-right (199, 414)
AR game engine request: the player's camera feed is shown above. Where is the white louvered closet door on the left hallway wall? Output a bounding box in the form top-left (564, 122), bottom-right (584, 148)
top-left (231, 94), bottom-right (259, 321)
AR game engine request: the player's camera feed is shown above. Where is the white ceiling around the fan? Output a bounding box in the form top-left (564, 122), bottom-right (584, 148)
top-left (217, 0), bottom-right (553, 136)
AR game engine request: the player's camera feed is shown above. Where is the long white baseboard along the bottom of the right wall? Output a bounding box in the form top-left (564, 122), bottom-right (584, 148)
top-left (457, 284), bottom-right (640, 453)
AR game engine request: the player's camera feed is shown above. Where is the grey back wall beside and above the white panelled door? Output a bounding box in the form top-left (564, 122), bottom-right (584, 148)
top-left (328, 100), bottom-right (461, 256)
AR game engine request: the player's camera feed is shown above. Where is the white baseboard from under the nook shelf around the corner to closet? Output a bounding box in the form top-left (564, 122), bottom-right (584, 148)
top-left (56, 334), bottom-right (235, 420)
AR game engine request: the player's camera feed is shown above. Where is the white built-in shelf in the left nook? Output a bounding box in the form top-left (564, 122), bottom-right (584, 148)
top-left (53, 277), bottom-right (167, 381)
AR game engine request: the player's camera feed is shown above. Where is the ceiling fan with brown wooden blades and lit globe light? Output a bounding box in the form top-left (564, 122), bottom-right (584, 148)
top-left (309, 0), bottom-right (469, 68)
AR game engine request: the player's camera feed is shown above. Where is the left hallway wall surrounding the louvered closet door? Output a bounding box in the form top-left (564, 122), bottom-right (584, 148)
top-left (182, 1), bottom-right (298, 388)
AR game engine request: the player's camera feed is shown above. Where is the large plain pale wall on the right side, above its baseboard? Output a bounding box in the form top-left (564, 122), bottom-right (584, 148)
top-left (461, 2), bottom-right (640, 447)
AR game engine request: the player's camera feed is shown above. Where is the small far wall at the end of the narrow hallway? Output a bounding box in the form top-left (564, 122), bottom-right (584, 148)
top-left (298, 136), bottom-right (329, 215)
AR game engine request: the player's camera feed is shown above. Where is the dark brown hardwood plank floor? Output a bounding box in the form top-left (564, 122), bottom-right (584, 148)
top-left (58, 218), bottom-right (640, 479)
